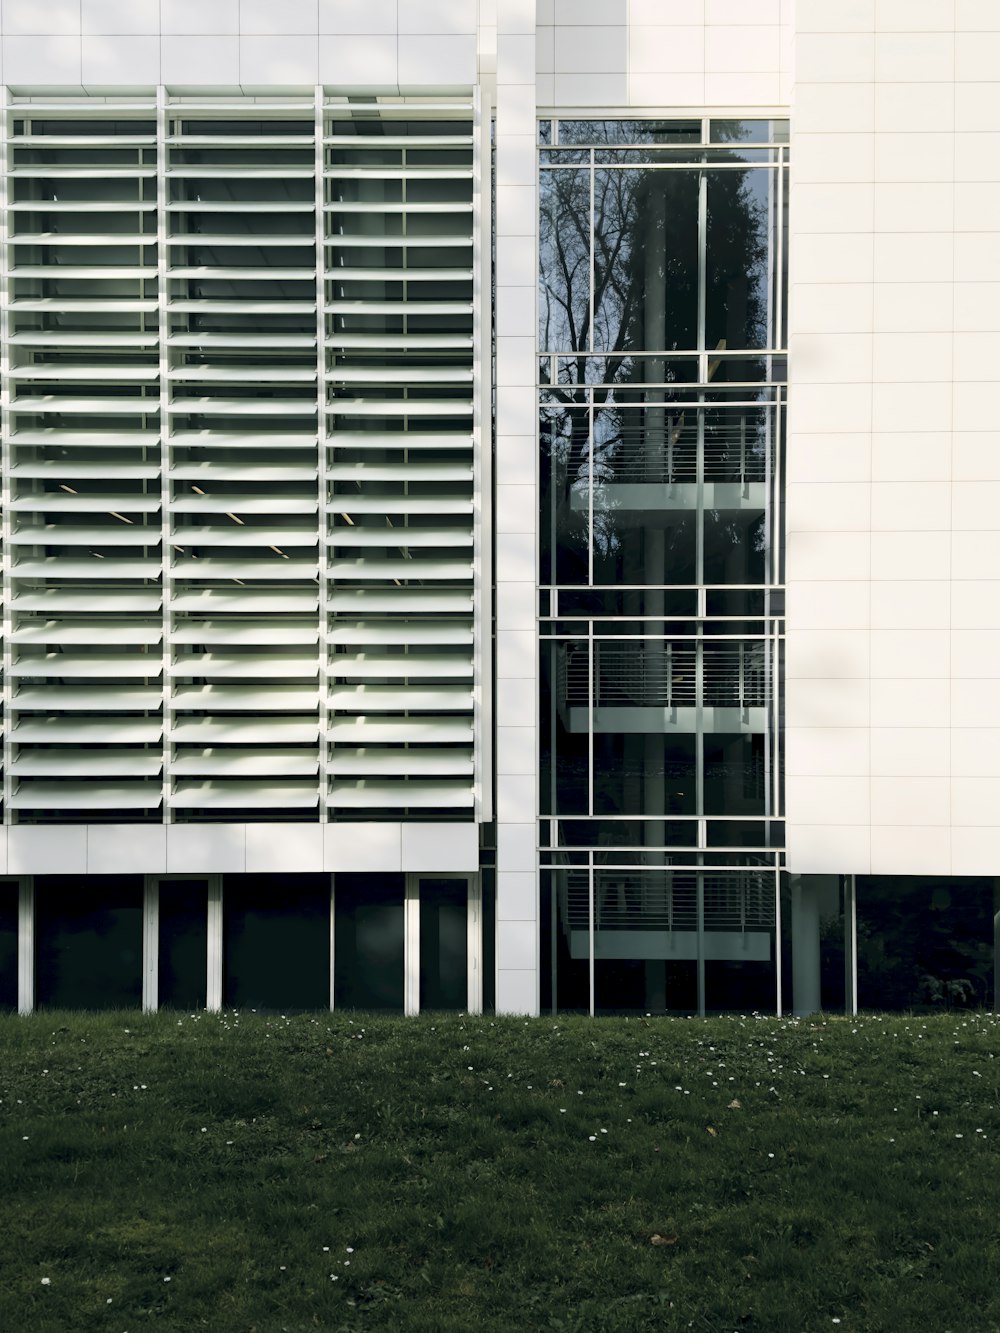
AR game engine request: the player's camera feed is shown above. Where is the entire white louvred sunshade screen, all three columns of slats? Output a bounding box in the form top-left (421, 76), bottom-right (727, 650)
top-left (3, 92), bottom-right (477, 821)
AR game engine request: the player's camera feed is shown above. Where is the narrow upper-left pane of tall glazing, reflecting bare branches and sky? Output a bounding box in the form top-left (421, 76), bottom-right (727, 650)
top-left (539, 171), bottom-right (591, 352)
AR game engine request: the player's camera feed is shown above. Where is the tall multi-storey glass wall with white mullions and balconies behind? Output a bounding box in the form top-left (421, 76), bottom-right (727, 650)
top-left (539, 119), bottom-right (787, 1012)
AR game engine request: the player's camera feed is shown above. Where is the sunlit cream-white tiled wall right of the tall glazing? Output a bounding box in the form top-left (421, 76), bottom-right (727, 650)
top-left (787, 0), bottom-right (1000, 874)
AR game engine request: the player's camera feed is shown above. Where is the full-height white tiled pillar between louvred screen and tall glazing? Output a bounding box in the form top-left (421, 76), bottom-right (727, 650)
top-left (496, 0), bottom-right (539, 1014)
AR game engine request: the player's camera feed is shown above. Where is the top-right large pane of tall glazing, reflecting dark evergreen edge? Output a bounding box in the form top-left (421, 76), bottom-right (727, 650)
top-left (705, 171), bottom-right (773, 351)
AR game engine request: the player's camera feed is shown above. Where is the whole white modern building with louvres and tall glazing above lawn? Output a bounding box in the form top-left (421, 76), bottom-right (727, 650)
top-left (0, 0), bottom-right (1000, 1013)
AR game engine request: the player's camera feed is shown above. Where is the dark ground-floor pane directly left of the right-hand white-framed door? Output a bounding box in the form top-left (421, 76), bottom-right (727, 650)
top-left (335, 874), bottom-right (404, 1012)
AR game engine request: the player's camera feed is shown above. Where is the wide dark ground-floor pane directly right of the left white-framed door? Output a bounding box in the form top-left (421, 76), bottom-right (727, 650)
top-left (223, 874), bottom-right (329, 1013)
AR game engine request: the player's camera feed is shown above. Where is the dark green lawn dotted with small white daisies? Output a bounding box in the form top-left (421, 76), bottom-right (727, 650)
top-left (0, 1012), bottom-right (1000, 1333)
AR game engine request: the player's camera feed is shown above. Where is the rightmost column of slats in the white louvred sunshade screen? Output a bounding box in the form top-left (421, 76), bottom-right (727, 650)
top-left (323, 112), bottom-right (476, 818)
